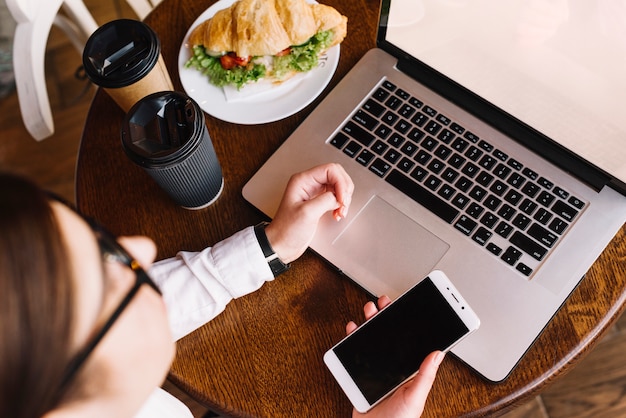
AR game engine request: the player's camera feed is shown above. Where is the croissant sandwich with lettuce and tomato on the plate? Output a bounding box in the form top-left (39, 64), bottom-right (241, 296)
top-left (186, 0), bottom-right (348, 88)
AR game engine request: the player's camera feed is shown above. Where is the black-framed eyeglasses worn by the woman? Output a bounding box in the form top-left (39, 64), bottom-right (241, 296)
top-left (52, 196), bottom-right (162, 389)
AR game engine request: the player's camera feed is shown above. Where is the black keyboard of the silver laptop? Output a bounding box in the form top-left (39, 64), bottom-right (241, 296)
top-left (329, 80), bottom-right (586, 277)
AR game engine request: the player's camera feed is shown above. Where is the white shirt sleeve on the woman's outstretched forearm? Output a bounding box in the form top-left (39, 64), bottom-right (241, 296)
top-left (149, 227), bottom-right (274, 340)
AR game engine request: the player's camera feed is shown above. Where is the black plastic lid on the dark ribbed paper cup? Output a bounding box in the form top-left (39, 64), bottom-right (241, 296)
top-left (122, 91), bottom-right (204, 168)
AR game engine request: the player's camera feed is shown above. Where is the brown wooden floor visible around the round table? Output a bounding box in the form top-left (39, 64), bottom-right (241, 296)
top-left (0, 0), bottom-right (626, 418)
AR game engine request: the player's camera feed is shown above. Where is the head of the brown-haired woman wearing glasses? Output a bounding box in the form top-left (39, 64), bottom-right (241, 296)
top-left (0, 174), bottom-right (174, 417)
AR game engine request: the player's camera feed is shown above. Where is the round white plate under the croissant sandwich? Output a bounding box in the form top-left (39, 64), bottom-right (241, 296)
top-left (178, 0), bottom-right (339, 125)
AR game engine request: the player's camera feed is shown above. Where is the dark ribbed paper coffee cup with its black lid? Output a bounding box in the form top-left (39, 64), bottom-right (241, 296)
top-left (121, 91), bottom-right (224, 209)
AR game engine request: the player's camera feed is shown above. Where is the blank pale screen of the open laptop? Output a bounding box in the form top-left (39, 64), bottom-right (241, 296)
top-left (379, 0), bottom-right (626, 189)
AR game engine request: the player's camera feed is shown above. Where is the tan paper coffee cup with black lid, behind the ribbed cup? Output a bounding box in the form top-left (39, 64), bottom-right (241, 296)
top-left (83, 19), bottom-right (174, 112)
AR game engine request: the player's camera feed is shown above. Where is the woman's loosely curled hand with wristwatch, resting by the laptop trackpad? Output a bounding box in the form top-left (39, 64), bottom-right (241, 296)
top-left (265, 164), bottom-right (354, 263)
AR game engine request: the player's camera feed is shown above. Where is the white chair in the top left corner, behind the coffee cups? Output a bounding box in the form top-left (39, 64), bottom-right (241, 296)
top-left (6, 0), bottom-right (98, 141)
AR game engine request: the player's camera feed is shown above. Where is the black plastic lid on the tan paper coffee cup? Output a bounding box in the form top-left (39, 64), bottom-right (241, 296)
top-left (83, 19), bottom-right (161, 88)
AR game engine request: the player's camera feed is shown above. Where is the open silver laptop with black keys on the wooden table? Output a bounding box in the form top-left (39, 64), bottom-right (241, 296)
top-left (243, 0), bottom-right (626, 382)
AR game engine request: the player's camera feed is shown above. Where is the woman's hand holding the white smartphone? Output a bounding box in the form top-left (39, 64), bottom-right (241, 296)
top-left (346, 296), bottom-right (444, 418)
